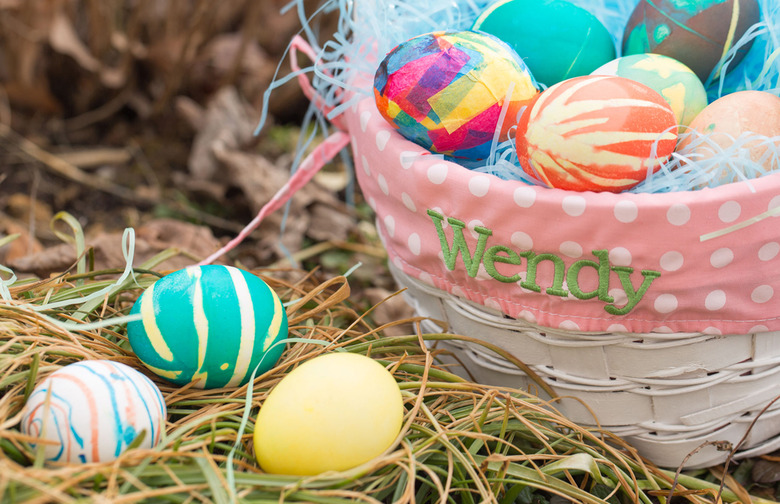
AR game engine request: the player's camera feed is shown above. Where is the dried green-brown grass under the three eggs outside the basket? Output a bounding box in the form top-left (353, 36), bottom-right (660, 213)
top-left (0, 239), bottom-right (755, 503)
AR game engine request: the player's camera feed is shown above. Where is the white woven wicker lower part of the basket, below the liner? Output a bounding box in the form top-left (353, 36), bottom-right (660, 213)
top-left (391, 265), bottom-right (780, 468)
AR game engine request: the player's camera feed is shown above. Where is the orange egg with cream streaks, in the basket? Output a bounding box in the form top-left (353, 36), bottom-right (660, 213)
top-left (516, 75), bottom-right (677, 192)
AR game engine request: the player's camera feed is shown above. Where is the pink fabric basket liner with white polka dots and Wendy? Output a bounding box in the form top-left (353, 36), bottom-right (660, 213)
top-left (344, 89), bottom-right (780, 334)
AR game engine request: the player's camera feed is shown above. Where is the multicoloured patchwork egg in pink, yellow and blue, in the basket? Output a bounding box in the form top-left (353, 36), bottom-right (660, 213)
top-left (374, 31), bottom-right (538, 160)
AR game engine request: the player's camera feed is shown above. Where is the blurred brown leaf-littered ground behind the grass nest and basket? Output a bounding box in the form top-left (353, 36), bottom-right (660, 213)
top-left (0, 0), bottom-right (407, 326)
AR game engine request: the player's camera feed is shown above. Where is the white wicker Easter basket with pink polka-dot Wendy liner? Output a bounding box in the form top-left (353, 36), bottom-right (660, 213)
top-left (235, 0), bottom-right (780, 467)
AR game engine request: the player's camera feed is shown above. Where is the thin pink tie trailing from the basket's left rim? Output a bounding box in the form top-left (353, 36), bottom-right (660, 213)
top-left (198, 35), bottom-right (350, 265)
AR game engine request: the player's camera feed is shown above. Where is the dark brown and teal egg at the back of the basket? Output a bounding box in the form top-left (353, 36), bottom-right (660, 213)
top-left (623, 0), bottom-right (760, 83)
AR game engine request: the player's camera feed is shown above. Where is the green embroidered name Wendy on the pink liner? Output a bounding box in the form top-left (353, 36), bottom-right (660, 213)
top-left (428, 210), bottom-right (661, 315)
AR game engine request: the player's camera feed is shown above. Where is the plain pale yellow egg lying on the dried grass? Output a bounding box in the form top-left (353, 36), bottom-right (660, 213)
top-left (254, 352), bottom-right (404, 475)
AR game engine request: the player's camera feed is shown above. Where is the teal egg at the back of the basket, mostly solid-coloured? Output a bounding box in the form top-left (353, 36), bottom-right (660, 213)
top-left (472, 0), bottom-right (615, 86)
